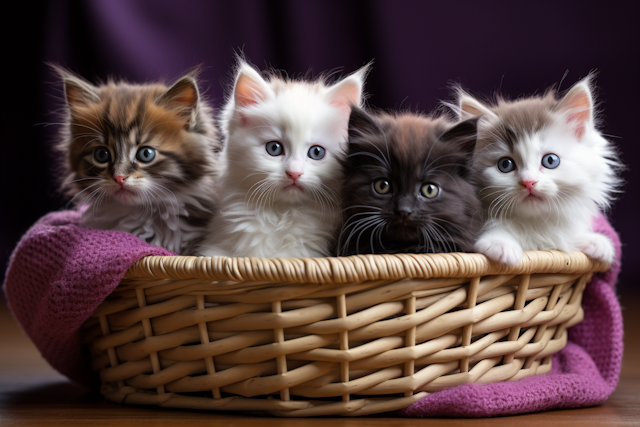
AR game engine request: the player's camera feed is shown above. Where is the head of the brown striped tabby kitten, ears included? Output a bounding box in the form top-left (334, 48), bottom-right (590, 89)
top-left (64, 74), bottom-right (218, 205)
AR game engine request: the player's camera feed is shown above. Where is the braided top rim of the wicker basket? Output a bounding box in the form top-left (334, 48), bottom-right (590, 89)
top-left (124, 250), bottom-right (611, 283)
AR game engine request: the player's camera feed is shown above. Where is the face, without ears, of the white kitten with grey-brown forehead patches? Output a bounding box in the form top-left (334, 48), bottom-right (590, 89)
top-left (464, 85), bottom-right (609, 219)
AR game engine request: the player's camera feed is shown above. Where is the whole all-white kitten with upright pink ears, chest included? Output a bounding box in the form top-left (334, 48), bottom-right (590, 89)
top-left (196, 60), bottom-right (368, 258)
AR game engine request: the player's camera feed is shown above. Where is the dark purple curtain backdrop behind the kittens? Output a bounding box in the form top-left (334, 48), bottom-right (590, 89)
top-left (0, 0), bottom-right (640, 294)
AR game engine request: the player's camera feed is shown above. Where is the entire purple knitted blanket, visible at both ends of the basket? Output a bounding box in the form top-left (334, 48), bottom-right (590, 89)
top-left (4, 211), bottom-right (623, 417)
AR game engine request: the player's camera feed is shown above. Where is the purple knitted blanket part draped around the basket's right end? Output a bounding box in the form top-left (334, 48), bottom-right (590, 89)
top-left (400, 215), bottom-right (623, 417)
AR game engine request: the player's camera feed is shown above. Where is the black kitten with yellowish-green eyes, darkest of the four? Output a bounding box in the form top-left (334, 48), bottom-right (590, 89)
top-left (337, 108), bottom-right (482, 255)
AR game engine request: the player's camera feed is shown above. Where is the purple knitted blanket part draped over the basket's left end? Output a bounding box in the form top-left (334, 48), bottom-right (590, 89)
top-left (4, 211), bottom-right (175, 387)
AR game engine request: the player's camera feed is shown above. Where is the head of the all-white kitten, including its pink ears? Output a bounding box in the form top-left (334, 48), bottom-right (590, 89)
top-left (226, 66), bottom-right (362, 208)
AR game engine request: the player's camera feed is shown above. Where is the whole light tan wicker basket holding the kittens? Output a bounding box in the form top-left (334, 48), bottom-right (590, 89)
top-left (85, 251), bottom-right (609, 417)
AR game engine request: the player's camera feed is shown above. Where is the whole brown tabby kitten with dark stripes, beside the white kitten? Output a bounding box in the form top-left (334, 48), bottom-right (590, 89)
top-left (54, 67), bottom-right (220, 254)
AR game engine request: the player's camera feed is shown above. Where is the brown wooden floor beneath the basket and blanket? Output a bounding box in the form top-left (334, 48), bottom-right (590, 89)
top-left (0, 293), bottom-right (640, 427)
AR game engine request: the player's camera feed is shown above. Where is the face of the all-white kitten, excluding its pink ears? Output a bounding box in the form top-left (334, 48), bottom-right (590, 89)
top-left (228, 83), bottom-right (347, 204)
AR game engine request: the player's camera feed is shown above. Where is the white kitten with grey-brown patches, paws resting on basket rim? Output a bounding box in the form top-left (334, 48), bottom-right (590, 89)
top-left (459, 77), bottom-right (619, 265)
